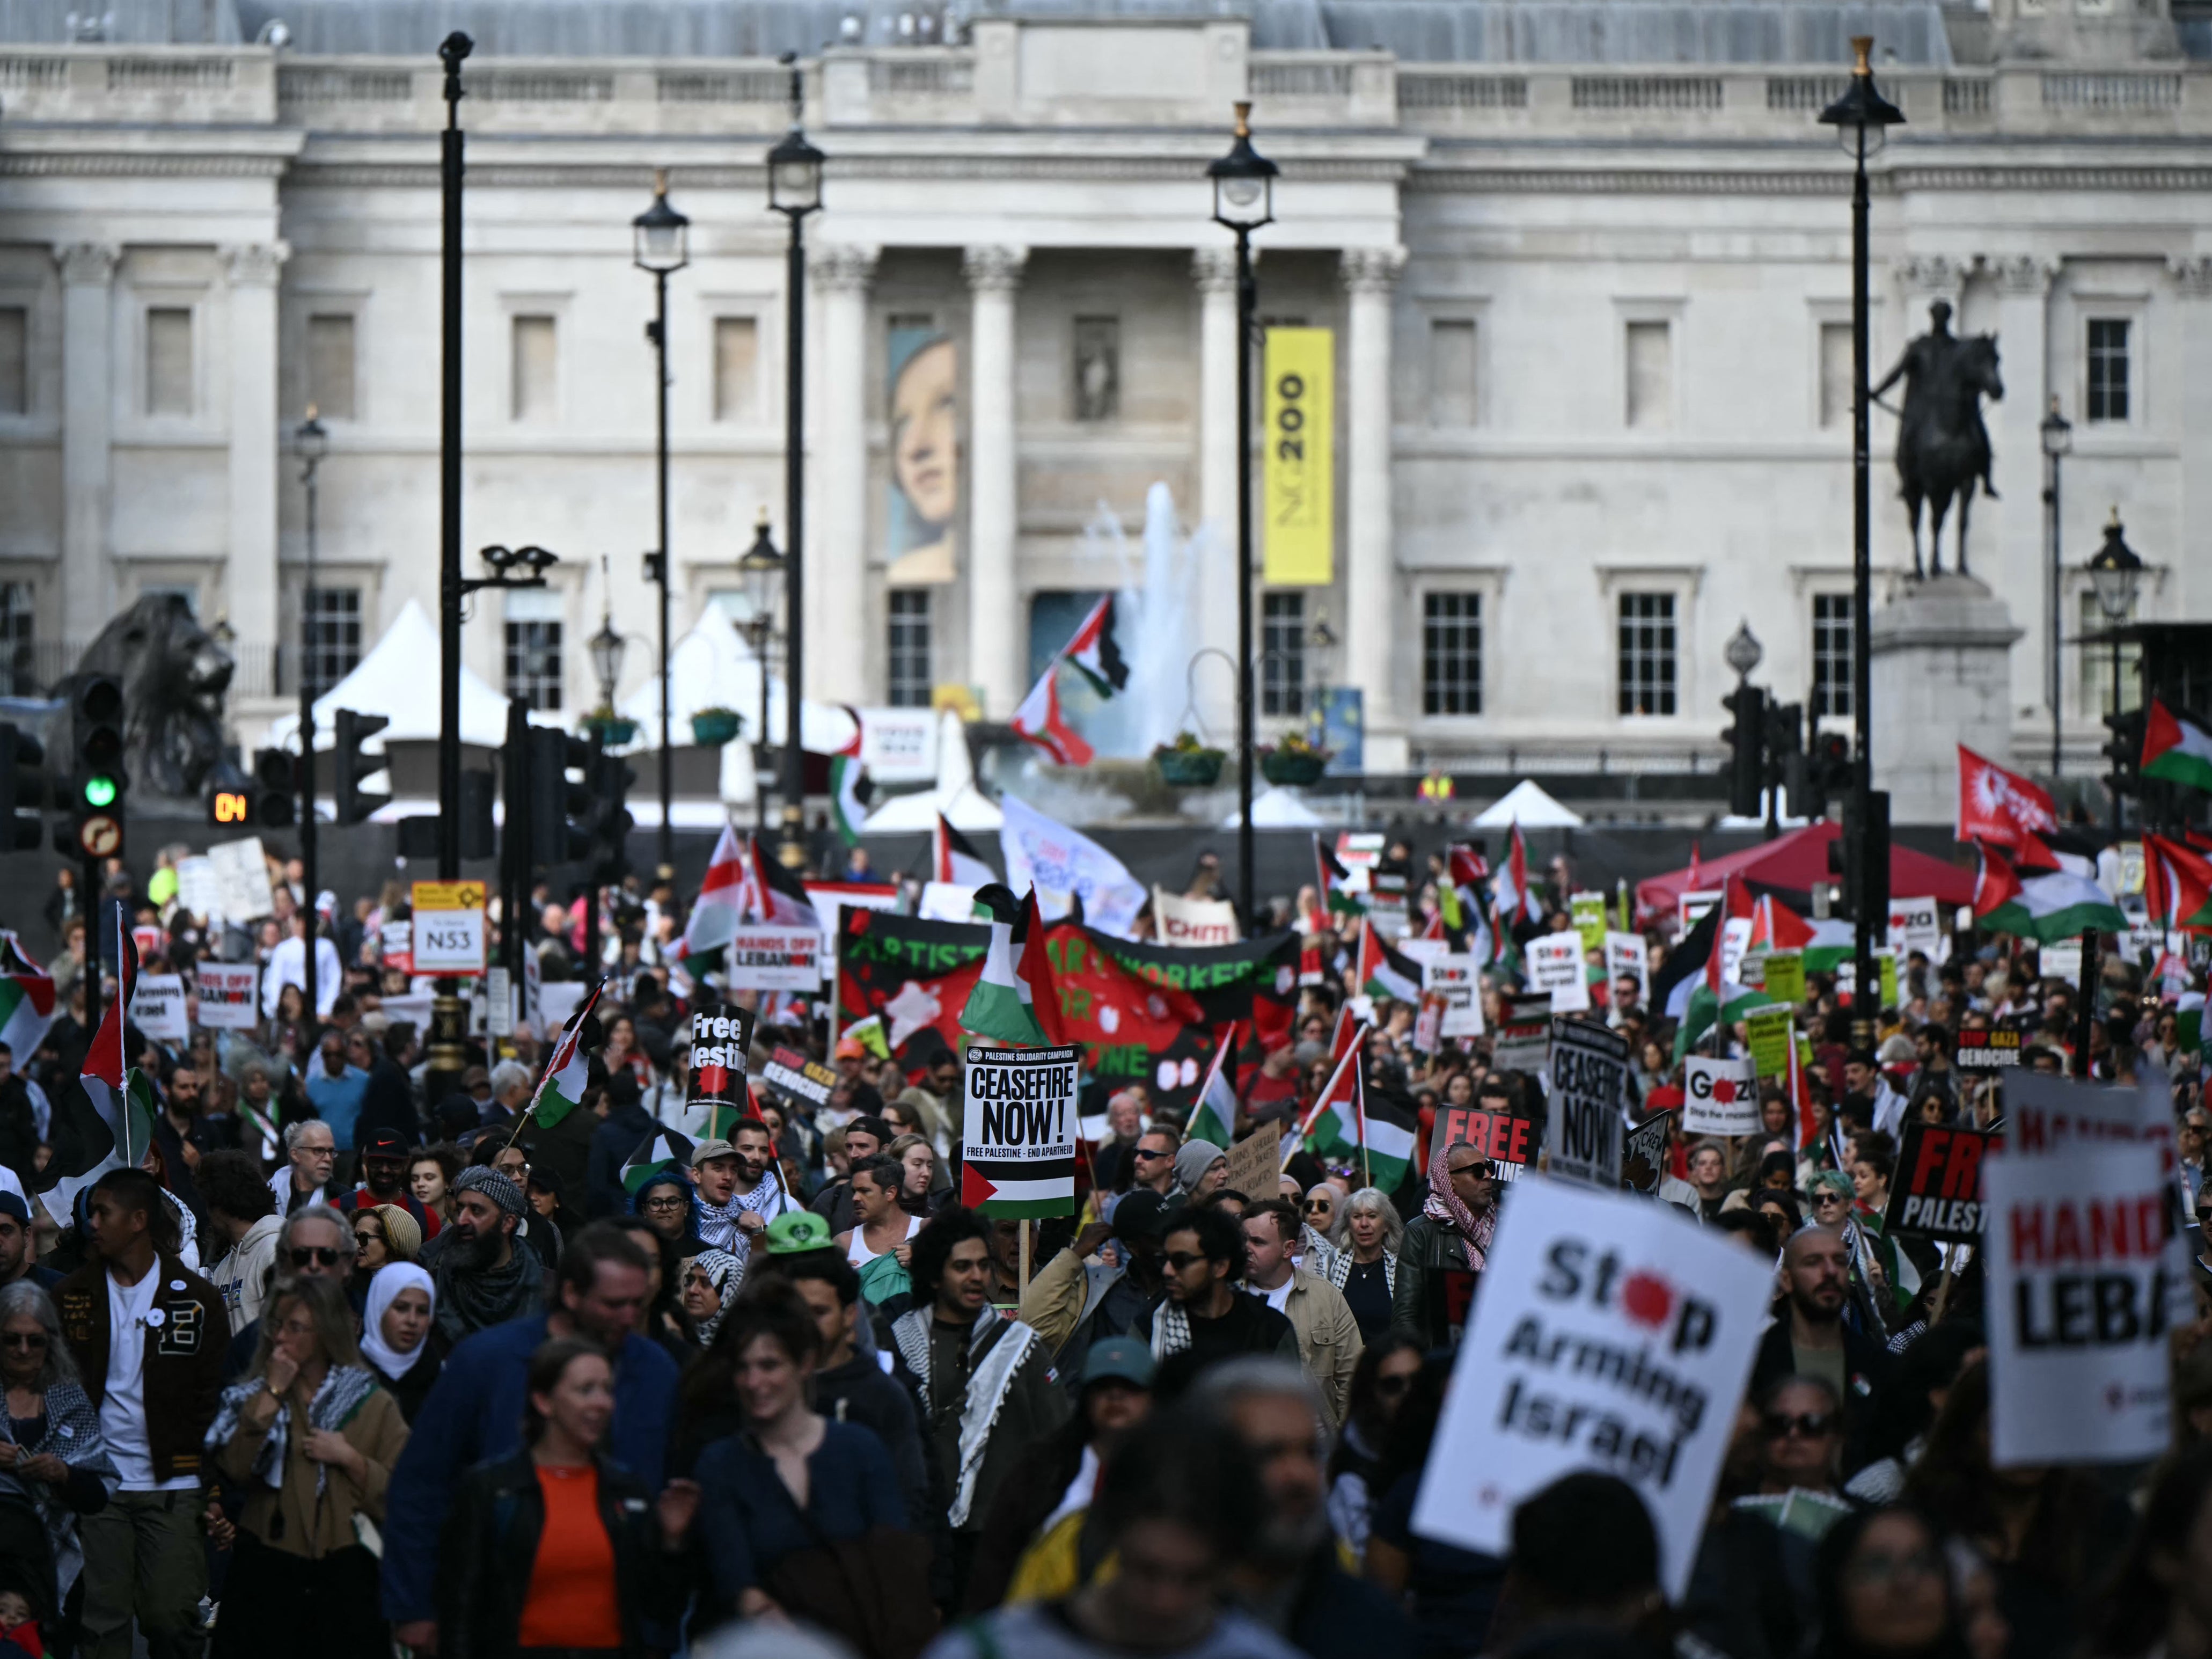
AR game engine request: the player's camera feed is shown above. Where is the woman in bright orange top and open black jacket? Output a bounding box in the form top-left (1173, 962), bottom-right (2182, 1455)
top-left (438, 1338), bottom-right (699, 1659)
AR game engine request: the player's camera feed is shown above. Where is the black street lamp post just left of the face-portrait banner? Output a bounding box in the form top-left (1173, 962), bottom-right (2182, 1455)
top-left (763, 55), bottom-right (825, 869)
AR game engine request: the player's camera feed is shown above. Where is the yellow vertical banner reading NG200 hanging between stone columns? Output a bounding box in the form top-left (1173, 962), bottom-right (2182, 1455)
top-left (1261, 327), bottom-right (1336, 588)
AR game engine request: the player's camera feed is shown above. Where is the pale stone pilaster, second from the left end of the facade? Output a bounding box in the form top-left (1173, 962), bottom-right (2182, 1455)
top-left (221, 241), bottom-right (292, 697)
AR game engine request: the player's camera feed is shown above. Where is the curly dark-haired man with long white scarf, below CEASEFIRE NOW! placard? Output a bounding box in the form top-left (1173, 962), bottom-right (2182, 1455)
top-left (891, 1205), bottom-right (1079, 1606)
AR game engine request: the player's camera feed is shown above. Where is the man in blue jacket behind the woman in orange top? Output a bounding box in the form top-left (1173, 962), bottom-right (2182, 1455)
top-left (383, 1221), bottom-right (677, 1650)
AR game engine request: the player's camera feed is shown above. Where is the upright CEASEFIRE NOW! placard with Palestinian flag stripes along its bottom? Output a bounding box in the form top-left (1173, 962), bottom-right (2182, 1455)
top-left (960, 1046), bottom-right (1080, 1217)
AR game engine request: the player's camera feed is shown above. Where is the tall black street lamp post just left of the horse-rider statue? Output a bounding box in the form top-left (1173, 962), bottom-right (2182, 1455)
top-left (1820, 35), bottom-right (1905, 1049)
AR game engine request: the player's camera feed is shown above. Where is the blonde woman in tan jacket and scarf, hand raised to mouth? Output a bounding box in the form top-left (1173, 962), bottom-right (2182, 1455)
top-left (206, 1278), bottom-right (407, 1659)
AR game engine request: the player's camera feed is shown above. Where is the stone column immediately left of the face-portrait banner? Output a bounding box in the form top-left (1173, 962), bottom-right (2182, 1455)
top-left (814, 245), bottom-right (883, 704)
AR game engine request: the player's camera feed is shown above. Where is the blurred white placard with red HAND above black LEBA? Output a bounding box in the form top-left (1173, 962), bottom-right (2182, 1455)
top-left (1982, 1146), bottom-right (2172, 1469)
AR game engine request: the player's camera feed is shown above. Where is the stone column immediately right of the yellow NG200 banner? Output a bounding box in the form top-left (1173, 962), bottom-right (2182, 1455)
top-left (1338, 248), bottom-right (1409, 772)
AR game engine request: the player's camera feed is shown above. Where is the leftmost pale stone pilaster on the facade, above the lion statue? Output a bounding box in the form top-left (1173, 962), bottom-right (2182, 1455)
top-left (55, 241), bottom-right (122, 666)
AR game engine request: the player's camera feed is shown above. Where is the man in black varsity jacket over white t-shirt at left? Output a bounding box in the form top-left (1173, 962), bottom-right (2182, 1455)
top-left (53, 1170), bottom-right (230, 1659)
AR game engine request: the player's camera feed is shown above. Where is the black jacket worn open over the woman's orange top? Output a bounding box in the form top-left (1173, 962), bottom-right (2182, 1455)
top-left (438, 1451), bottom-right (690, 1659)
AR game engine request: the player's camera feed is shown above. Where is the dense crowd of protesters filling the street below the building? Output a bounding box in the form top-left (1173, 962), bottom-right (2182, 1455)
top-left (0, 845), bottom-right (2212, 1659)
